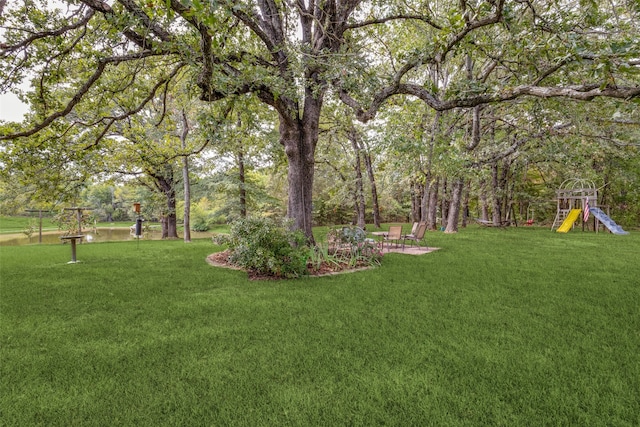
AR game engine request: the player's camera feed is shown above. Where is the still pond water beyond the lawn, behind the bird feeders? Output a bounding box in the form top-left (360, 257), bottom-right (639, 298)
top-left (0, 228), bottom-right (211, 246)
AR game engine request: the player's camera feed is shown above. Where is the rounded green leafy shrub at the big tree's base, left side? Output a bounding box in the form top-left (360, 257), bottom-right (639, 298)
top-left (228, 218), bottom-right (309, 278)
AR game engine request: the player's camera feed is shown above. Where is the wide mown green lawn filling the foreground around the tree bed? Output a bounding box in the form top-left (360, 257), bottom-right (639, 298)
top-left (0, 227), bottom-right (640, 426)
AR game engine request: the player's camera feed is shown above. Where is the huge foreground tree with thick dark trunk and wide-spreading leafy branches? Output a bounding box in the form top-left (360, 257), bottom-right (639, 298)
top-left (0, 0), bottom-right (640, 238)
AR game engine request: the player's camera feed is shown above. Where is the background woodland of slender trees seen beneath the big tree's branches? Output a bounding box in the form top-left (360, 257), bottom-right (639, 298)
top-left (1, 91), bottom-right (640, 237)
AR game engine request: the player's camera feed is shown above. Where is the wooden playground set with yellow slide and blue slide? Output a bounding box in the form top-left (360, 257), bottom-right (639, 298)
top-left (551, 179), bottom-right (629, 234)
